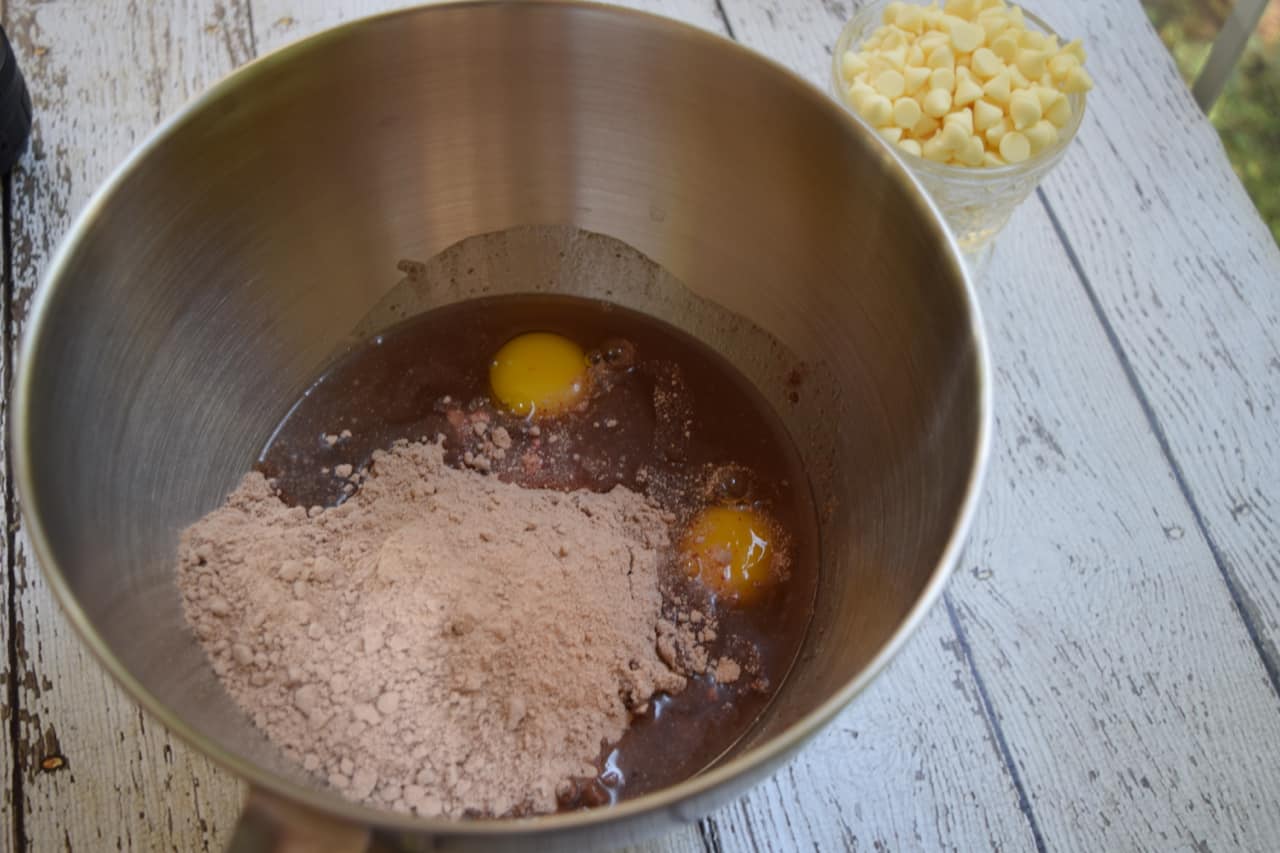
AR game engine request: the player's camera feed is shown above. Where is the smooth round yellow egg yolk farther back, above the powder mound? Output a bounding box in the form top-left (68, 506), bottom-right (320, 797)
top-left (489, 332), bottom-right (588, 416)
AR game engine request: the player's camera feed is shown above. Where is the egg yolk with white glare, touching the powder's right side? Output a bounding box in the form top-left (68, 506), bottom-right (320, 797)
top-left (680, 506), bottom-right (774, 605)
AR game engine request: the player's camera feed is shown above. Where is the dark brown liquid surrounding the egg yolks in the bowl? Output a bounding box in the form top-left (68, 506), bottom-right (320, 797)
top-left (257, 296), bottom-right (818, 808)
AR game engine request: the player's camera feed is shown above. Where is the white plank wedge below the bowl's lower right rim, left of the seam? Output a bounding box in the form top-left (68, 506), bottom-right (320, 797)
top-left (714, 606), bottom-right (1034, 850)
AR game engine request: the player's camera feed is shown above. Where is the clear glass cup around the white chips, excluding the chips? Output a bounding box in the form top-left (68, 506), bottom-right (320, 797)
top-left (831, 0), bottom-right (1085, 257)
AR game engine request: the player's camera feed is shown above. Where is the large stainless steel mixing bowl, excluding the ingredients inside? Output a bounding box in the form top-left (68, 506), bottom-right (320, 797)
top-left (13, 1), bottom-right (989, 847)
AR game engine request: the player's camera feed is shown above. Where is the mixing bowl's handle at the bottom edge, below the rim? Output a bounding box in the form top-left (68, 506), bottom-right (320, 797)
top-left (227, 788), bottom-right (375, 853)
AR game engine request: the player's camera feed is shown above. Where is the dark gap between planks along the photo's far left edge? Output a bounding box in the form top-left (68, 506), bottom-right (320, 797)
top-left (0, 174), bottom-right (26, 850)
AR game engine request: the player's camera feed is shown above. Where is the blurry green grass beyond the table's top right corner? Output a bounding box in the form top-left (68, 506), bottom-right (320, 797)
top-left (1144, 0), bottom-right (1280, 243)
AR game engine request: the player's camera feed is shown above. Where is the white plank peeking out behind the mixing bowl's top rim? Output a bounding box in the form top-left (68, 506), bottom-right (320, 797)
top-left (252, 0), bottom-right (724, 53)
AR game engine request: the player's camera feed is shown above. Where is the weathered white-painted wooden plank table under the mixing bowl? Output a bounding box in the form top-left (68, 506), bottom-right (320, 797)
top-left (0, 0), bottom-right (1280, 852)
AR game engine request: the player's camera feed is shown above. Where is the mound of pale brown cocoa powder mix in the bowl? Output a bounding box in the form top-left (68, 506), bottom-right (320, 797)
top-left (178, 430), bottom-right (696, 816)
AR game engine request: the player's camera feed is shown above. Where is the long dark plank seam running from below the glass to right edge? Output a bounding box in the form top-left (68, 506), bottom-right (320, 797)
top-left (1036, 187), bottom-right (1280, 698)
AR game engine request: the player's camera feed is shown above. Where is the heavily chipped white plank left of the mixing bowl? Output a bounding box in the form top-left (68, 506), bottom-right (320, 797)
top-left (5, 0), bottom-right (248, 850)
